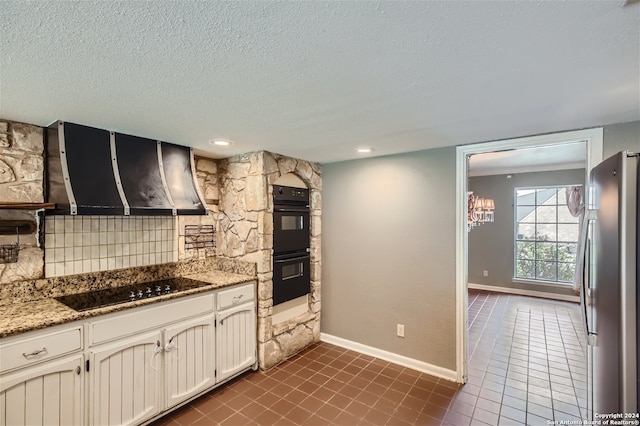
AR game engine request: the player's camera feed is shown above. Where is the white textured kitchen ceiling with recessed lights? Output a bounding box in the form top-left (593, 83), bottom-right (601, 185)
top-left (0, 0), bottom-right (640, 162)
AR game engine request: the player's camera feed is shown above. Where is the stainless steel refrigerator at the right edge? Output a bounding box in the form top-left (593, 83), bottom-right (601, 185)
top-left (579, 151), bottom-right (640, 420)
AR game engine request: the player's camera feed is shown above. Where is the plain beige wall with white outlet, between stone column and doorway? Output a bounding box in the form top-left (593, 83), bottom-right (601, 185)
top-left (321, 147), bottom-right (456, 370)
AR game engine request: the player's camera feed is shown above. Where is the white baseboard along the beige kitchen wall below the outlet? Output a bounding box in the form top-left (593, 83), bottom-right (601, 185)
top-left (320, 333), bottom-right (463, 383)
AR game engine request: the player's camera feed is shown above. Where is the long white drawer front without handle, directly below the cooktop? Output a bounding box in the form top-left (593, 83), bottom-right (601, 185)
top-left (88, 293), bottom-right (213, 346)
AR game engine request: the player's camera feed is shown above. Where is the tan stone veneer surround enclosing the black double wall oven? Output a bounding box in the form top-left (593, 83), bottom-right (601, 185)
top-left (217, 151), bottom-right (322, 370)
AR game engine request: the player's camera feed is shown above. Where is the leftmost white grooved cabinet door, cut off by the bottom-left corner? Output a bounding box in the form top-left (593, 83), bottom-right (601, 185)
top-left (0, 354), bottom-right (84, 426)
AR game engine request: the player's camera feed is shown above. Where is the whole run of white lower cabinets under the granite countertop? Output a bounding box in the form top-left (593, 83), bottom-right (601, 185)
top-left (0, 282), bottom-right (257, 426)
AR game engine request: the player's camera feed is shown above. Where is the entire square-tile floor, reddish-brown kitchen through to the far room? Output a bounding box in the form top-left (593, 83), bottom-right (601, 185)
top-left (154, 291), bottom-right (585, 426)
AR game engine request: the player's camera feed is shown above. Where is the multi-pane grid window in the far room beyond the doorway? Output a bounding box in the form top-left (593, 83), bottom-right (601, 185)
top-left (515, 186), bottom-right (579, 283)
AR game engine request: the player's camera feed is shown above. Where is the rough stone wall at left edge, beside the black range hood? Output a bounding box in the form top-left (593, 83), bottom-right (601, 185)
top-left (0, 119), bottom-right (44, 284)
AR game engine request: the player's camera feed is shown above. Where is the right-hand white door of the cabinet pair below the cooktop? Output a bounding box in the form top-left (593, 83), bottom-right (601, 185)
top-left (164, 314), bottom-right (215, 407)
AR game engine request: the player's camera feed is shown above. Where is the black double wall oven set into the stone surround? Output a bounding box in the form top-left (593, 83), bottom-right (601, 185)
top-left (273, 185), bottom-right (311, 305)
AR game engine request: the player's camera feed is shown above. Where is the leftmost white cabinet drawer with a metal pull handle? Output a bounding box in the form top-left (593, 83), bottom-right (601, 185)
top-left (0, 326), bottom-right (82, 373)
